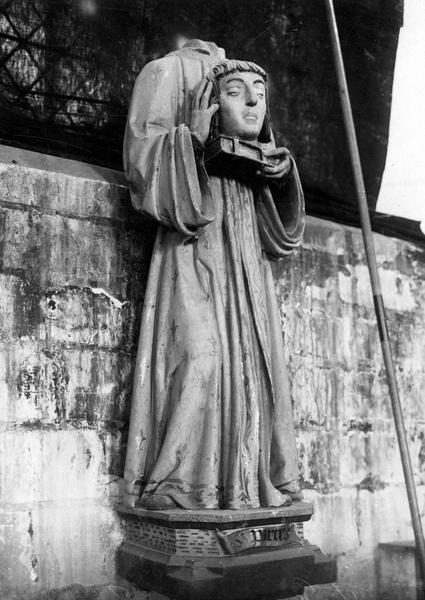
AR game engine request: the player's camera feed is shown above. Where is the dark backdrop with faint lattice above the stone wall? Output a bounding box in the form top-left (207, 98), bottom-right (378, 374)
top-left (0, 0), bottom-right (423, 243)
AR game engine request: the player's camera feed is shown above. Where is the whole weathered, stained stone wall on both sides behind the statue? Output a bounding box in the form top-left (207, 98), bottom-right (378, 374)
top-left (0, 147), bottom-right (425, 600)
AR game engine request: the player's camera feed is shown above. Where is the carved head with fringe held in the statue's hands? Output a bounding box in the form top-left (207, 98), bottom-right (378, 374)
top-left (208, 60), bottom-right (271, 143)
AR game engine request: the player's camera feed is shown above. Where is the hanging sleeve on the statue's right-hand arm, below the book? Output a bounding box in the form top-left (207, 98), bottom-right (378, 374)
top-left (257, 159), bottom-right (305, 259)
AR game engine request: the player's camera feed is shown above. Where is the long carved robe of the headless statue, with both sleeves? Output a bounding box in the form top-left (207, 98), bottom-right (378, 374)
top-left (124, 41), bottom-right (304, 509)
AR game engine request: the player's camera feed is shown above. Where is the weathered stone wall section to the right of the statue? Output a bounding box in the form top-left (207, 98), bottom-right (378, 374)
top-left (274, 219), bottom-right (425, 600)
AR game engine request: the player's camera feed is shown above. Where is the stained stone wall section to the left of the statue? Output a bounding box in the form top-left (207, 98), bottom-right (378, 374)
top-left (0, 147), bottom-right (153, 600)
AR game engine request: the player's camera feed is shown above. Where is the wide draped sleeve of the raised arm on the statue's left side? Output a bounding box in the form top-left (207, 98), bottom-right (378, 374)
top-left (124, 57), bottom-right (214, 236)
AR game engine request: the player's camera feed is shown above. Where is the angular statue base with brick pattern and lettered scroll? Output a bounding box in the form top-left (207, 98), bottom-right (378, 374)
top-left (118, 502), bottom-right (336, 600)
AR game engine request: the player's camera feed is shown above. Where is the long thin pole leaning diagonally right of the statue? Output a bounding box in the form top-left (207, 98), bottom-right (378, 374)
top-left (325, 0), bottom-right (425, 598)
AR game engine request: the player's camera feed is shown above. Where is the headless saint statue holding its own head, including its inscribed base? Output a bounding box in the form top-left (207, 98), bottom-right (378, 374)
top-left (117, 40), bottom-right (336, 600)
